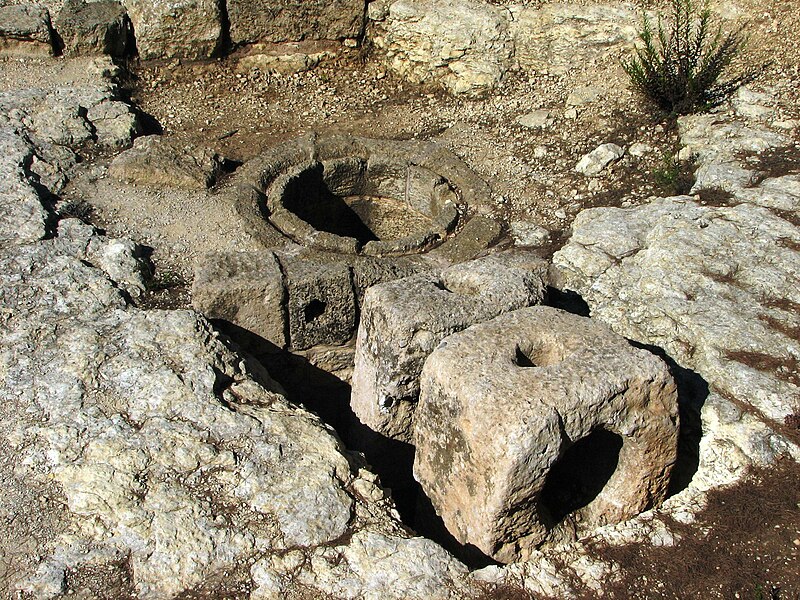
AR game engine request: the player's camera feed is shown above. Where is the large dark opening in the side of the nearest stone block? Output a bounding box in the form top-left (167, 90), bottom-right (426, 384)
top-left (539, 428), bottom-right (622, 527)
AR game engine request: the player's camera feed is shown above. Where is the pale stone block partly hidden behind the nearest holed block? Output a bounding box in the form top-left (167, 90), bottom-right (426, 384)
top-left (351, 252), bottom-right (546, 442)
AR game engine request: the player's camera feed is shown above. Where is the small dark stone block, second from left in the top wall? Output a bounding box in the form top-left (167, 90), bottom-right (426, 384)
top-left (55, 0), bottom-right (133, 56)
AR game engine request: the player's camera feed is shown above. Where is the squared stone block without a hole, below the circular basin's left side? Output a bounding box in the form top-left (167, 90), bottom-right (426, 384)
top-left (192, 252), bottom-right (287, 348)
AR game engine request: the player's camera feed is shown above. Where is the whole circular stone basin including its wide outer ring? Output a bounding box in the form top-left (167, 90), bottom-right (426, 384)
top-left (227, 135), bottom-right (488, 256)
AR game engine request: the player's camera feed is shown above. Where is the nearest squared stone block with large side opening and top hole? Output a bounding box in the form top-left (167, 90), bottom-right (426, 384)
top-left (414, 306), bottom-right (678, 562)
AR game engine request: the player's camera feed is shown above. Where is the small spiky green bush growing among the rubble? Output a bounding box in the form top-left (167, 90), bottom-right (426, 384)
top-left (622, 0), bottom-right (757, 115)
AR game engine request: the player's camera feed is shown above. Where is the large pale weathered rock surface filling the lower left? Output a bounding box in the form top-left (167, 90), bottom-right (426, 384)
top-left (0, 123), bottom-right (466, 598)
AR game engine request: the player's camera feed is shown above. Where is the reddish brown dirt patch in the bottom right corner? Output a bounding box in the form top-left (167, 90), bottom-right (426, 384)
top-left (598, 459), bottom-right (800, 600)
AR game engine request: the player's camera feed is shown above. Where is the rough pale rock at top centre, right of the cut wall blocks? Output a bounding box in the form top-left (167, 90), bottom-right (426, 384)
top-left (369, 0), bottom-right (514, 95)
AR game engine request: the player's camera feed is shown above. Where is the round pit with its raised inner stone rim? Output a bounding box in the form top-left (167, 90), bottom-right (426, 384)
top-left (267, 157), bottom-right (458, 255)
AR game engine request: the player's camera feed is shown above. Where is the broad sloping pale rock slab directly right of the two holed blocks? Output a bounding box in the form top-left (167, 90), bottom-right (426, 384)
top-left (554, 197), bottom-right (800, 422)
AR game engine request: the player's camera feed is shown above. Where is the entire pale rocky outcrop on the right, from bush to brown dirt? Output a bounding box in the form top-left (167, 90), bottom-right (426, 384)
top-left (553, 114), bottom-right (800, 500)
